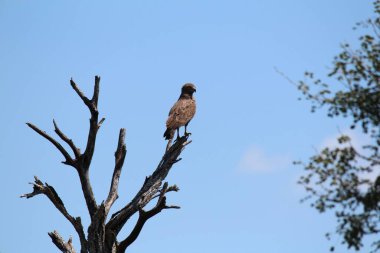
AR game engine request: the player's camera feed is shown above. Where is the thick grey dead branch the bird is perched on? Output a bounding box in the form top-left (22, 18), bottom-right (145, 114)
top-left (106, 136), bottom-right (190, 237)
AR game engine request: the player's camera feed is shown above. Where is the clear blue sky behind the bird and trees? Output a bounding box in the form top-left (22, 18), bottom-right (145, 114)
top-left (0, 0), bottom-right (372, 253)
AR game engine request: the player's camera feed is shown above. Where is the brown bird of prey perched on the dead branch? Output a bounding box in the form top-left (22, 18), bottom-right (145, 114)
top-left (164, 83), bottom-right (196, 141)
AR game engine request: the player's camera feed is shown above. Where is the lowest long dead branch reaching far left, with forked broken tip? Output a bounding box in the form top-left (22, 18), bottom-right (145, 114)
top-left (21, 176), bottom-right (87, 252)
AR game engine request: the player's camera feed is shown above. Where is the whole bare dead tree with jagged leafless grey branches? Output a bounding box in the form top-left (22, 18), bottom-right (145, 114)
top-left (21, 76), bottom-right (191, 253)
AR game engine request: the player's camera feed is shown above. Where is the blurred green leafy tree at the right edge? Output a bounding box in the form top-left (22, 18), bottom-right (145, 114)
top-left (297, 0), bottom-right (380, 251)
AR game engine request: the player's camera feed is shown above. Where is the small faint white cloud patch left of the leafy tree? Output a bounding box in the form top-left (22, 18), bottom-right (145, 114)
top-left (239, 146), bottom-right (291, 172)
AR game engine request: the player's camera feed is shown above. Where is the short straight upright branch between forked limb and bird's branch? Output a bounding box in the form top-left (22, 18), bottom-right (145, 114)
top-left (105, 128), bottom-right (127, 215)
